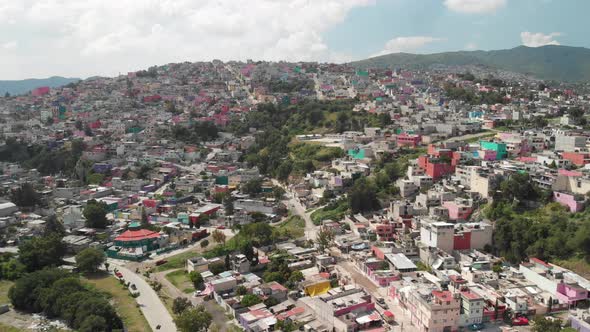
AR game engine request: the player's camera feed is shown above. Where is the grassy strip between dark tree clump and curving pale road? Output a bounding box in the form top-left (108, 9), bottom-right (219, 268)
top-left (85, 276), bottom-right (152, 332)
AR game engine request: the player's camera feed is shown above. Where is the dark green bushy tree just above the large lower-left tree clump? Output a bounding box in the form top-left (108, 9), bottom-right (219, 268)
top-left (18, 234), bottom-right (66, 272)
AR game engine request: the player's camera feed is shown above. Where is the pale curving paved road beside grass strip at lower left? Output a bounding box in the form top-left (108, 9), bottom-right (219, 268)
top-left (109, 261), bottom-right (177, 332)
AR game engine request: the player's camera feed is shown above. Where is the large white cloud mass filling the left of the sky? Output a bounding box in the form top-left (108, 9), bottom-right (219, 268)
top-left (0, 0), bottom-right (376, 79)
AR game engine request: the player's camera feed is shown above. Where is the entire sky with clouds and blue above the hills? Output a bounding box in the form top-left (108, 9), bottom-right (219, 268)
top-left (0, 0), bottom-right (590, 80)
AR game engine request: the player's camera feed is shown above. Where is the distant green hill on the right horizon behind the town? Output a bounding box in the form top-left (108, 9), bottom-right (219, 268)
top-left (351, 45), bottom-right (590, 82)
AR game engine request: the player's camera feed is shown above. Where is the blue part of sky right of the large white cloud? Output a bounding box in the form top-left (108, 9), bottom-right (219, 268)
top-left (325, 0), bottom-right (590, 58)
